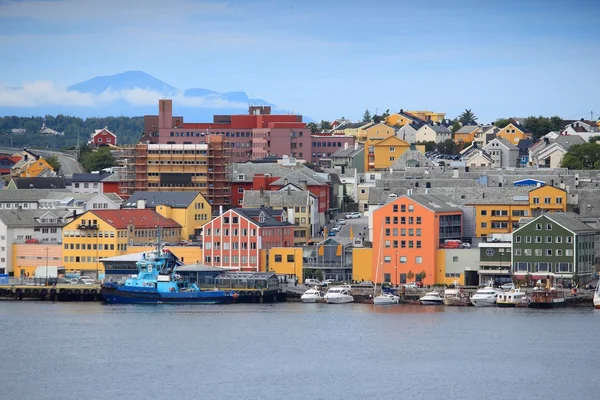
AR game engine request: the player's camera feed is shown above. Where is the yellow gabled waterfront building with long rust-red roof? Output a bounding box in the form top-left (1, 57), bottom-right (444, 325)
top-left (62, 209), bottom-right (181, 279)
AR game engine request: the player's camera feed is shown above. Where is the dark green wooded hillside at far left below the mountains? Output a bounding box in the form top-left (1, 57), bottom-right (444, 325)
top-left (0, 115), bottom-right (144, 150)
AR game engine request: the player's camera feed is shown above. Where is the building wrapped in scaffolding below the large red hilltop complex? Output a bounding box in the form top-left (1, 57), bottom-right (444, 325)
top-left (118, 139), bottom-right (231, 206)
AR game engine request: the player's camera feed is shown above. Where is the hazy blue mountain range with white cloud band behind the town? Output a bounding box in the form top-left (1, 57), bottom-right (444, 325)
top-left (0, 71), bottom-right (312, 122)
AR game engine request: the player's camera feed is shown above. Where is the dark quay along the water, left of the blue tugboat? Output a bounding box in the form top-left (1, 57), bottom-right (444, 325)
top-left (0, 284), bottom-right (102, 301)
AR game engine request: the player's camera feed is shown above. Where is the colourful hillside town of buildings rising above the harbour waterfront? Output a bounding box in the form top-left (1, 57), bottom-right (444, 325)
top-left (0, 99), bottom-right (600, 306)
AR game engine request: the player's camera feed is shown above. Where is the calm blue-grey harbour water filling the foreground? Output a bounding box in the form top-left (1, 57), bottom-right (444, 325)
top-left (0, 301), bottom-right (600, 400)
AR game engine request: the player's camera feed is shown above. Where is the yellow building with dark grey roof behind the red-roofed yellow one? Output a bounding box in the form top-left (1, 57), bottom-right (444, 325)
top-left (125, 192), bottom-right (212, 240)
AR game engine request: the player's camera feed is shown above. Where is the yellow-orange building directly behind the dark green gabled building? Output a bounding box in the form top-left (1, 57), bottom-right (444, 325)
top-left (474, 185), bottom-right (567, 237)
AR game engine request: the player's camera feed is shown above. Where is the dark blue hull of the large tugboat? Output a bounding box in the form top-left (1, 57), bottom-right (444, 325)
top-left (101, 289), bottom-right (237, 304)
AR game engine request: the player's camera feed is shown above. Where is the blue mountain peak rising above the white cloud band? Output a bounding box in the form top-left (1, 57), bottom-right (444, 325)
top-left (68, 71), bottom-right (177, 94)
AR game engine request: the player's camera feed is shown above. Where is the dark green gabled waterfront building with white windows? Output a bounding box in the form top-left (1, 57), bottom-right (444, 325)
top-left (511, 213), bottom-right (598, 282)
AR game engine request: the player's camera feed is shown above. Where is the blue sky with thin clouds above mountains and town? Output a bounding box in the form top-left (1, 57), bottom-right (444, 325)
top-left (0, 0), bottom-right (600, 123)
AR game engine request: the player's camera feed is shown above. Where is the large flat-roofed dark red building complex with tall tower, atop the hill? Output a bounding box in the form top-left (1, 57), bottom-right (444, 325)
top-left (142, 100), bottom-right (311, 162)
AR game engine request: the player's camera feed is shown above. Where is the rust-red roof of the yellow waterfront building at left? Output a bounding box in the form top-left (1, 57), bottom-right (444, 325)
top-left (90, 209), bottom-right (181, 229)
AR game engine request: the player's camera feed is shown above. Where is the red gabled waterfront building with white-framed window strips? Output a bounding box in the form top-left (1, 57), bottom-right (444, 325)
top-left (202, 208), bottom-right (294, 271)
